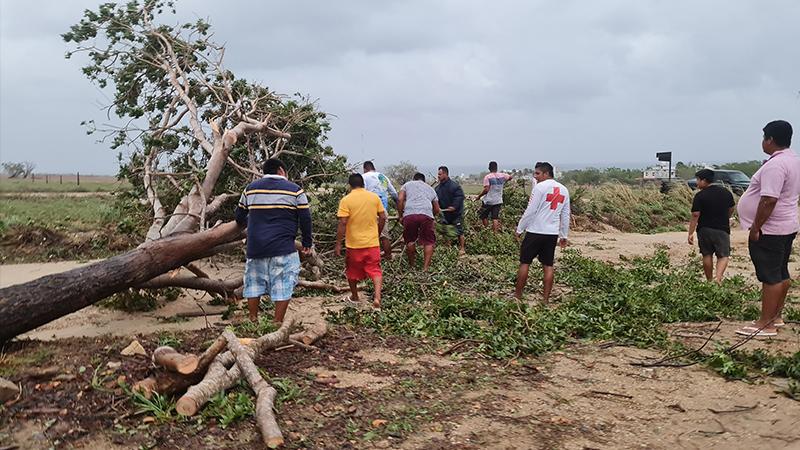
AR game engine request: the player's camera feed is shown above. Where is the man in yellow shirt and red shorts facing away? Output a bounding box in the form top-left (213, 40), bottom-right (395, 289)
top-left (335, 173), bottom-right (386, 308)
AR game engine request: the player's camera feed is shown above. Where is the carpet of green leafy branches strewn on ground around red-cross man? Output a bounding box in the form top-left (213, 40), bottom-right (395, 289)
top-left (334, 244), bottom-right (757, 358)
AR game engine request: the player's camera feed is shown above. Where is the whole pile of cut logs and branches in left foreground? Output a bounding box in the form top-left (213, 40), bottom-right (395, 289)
top-left (133, 319), bottom-right (328, 448)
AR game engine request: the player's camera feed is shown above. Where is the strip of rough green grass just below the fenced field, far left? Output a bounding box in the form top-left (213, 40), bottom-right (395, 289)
top-left (0, 195), bottom-right (114, 232)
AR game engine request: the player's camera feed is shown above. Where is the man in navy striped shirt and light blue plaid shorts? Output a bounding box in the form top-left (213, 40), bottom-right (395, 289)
top-left (236, 159), bottom-right (312, 323)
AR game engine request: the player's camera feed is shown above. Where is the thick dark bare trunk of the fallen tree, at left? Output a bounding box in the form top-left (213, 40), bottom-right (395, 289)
top-left (0, 222), bottom-right (243, 342)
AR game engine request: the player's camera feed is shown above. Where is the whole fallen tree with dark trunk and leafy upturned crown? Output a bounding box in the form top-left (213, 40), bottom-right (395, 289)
top-left (0, 0), bottom-right (346, 340)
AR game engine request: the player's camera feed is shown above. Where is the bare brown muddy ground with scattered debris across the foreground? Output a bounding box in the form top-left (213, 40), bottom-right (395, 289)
top-left (0, 232), bottom-right (800, 449)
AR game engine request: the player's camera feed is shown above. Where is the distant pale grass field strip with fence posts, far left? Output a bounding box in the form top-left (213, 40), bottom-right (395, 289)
top-left (0, 174), bottom-right (129, 193)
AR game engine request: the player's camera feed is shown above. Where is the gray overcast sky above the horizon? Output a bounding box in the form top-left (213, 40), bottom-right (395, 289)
top-left (0, 0), bottom-right (800, 174)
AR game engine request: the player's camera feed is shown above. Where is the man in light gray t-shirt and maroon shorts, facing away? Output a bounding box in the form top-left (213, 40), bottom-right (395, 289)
top-left (397, 172), bottom-right (441, 270)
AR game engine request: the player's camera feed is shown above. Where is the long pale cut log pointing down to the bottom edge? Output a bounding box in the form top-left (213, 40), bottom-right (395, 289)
top-left (223, 330), bottom-right (283, 448)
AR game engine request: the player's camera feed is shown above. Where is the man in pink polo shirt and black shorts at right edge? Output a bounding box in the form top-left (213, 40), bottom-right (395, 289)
top-left (736, 120), bottom-right (800, 336)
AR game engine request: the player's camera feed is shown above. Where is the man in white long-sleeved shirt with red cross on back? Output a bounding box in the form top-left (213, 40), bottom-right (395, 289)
top-left (514, 162), bottom-right (570, 302)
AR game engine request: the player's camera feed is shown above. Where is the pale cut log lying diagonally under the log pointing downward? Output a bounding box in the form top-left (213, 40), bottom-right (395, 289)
top-left (175, 319), bottom-right (294, 416)
